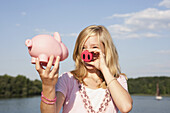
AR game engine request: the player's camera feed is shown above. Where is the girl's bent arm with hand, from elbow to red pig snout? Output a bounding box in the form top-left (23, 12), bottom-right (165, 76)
top-left (89, 49), bottom-right (133, 113)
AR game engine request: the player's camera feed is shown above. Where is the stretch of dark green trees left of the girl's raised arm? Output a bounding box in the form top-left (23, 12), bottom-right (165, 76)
top-left (0, 74), bottom-right (42, 98)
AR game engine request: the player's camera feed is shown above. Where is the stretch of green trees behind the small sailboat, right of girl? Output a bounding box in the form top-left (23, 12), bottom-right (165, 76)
top-left (127, 76), bottom-right (170, 96)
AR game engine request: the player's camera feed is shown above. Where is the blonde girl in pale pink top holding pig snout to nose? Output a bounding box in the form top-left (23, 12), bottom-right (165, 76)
top-left (36, 25), bottom-right (132, 113)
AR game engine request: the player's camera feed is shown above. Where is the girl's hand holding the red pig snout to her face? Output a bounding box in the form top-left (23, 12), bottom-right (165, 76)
top-left (88, 49), bottom-right (106, 70)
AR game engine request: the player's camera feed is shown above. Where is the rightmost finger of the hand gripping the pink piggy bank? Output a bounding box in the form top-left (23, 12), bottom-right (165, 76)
top-left (50, 56), bottom-right (60, 76)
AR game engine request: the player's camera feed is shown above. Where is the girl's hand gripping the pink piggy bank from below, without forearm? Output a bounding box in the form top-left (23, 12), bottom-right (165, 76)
top-left (36, 56), bottom-right (60, 87)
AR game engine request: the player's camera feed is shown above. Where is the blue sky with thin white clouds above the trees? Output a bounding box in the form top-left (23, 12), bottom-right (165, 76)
top-left (0, 0), bottom-right (170, 80)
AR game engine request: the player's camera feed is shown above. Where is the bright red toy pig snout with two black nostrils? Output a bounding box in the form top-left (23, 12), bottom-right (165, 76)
top-left (81, 50), bottom-right (93, 62)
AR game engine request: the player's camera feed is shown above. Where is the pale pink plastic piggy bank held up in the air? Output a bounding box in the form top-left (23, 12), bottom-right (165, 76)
top-left (25, 32), bottom-right (68, 66)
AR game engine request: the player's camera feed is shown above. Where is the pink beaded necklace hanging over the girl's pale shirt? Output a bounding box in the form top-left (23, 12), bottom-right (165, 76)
top-left (79, 83), bottom-right (111, 113)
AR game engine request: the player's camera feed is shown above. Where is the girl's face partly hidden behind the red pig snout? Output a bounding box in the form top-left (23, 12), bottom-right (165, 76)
top-left (82, 35), bottom-right (104, 70)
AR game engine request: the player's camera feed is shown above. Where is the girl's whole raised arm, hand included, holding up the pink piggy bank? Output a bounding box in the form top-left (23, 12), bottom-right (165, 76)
top-left (36, 56), bottom-right (65, 113)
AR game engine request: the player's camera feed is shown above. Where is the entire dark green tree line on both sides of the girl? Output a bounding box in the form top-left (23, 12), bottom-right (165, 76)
top-left (0, 74), bottom-right (170, 98)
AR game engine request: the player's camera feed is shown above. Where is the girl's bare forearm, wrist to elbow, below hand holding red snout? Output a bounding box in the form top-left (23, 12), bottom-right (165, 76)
top-left (101, 67), bottom-right (133, 113)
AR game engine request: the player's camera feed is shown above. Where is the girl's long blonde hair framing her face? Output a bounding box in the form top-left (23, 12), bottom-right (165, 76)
top-left (71, 25), bottom-right (121, 87)
